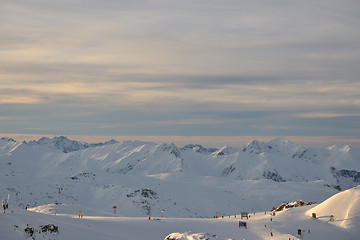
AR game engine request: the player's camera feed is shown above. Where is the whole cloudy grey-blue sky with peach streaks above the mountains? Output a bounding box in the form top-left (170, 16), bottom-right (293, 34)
top-left (0, 0), bottom-right (360, 147)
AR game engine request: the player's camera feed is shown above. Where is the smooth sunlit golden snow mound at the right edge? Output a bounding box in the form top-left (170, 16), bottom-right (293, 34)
top-left (307, 185), bottom-right (360, 230)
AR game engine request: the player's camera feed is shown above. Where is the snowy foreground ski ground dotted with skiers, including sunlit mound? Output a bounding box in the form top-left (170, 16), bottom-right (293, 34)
top-left (0, 186), bottom-right (360, 240)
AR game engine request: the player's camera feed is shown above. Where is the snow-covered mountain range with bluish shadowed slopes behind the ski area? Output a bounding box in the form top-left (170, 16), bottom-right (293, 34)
top-left (0, 137), bottom-right (360, 217)
